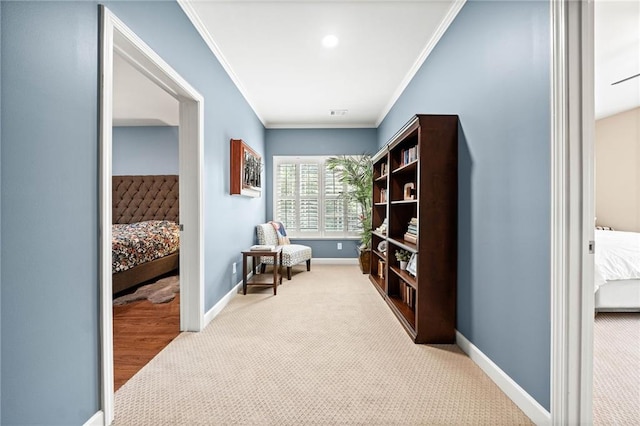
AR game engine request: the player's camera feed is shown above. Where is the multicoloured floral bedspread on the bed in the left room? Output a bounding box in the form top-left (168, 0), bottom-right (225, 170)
top-left (112, 220), bottom-right (180, 274)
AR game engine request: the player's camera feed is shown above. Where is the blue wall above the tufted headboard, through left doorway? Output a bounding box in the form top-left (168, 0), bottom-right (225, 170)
top-left (112, 126), bottom-right (179, 176)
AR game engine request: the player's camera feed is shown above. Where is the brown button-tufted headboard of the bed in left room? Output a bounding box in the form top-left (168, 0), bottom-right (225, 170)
top-left (111, 175), bottom-right (179, 223)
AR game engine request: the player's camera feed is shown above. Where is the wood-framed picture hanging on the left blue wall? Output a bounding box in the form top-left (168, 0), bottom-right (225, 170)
top-left (229, 139), bottom-right (262, 197)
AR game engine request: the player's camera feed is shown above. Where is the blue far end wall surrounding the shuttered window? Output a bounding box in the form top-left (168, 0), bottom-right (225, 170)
top-left (264, 129), bottom-right (378, 258)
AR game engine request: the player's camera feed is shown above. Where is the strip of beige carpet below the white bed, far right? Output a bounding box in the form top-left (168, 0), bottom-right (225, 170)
top-left (593, 313), bottom-right (640, 425)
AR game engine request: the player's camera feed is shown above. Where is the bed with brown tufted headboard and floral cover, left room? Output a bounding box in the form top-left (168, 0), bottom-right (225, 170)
top-left (112, 175), bottom-right (180, 294)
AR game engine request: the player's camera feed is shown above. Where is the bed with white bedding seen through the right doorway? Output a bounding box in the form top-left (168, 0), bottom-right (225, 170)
top-left (594, 229), bottom-right (640, 312)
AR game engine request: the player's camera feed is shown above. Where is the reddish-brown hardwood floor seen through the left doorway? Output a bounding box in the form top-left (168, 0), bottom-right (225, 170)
top-left (113, 294), bottom-right (180, 390)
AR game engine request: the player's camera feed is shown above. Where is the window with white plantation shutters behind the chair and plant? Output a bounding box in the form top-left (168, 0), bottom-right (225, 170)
top-left (273, 156), bottom-right (362, 238)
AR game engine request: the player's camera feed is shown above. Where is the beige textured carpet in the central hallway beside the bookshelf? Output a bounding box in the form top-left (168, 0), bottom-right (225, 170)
top-left (115, 265), bottom-right (531, 425)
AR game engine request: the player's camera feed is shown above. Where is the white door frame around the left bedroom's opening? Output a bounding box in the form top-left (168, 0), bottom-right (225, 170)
top-left (99, 5), bottom-right (204, 425)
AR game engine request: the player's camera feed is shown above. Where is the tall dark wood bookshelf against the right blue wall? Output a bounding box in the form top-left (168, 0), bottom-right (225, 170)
top-left (370, 115), bottom-right (458, 344)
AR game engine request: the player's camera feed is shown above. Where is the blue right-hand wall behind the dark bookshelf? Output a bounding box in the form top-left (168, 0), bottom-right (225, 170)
top-left (379, 1), bottom-right (551, 410)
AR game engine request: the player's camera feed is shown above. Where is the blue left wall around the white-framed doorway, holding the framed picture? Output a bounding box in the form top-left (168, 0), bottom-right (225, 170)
top-left (0, 1), bottom-right (265, 425)
